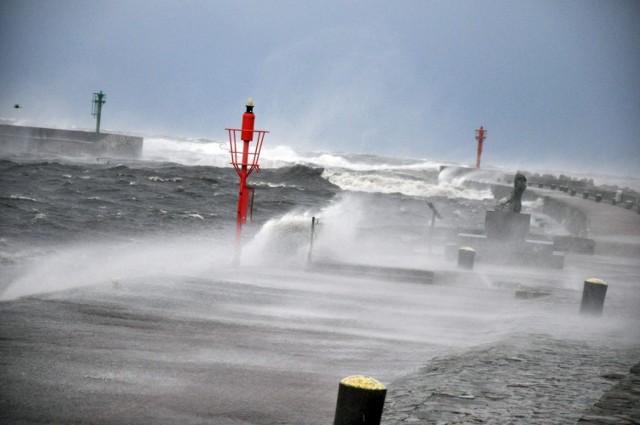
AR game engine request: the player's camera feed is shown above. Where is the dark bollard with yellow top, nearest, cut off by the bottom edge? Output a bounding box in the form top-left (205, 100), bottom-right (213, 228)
top-left (333, 375), bottom-right (387, 425)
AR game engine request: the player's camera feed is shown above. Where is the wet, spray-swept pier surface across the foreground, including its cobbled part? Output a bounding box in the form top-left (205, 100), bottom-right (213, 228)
top-left (0, 176), bottom-right (640, 425)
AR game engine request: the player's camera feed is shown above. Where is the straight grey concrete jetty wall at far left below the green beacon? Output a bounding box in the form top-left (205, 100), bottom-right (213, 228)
top-left (0, 124), bottom-right (143, 159)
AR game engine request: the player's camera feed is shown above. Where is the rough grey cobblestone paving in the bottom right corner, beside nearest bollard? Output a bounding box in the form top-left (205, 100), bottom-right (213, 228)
top-left (382, 335), bottom-right (640, 425)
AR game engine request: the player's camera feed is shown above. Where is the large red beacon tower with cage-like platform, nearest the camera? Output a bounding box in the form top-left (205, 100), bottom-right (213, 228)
top-left (225, 98), bottom-right (268, 262)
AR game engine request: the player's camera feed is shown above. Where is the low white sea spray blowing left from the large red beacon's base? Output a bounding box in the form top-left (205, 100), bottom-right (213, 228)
top-left (1, 235), bottom-right (231, 300)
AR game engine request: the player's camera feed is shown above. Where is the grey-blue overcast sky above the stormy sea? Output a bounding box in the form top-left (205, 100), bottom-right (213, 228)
top-left (0, 0), bottom-right (640, 175)
